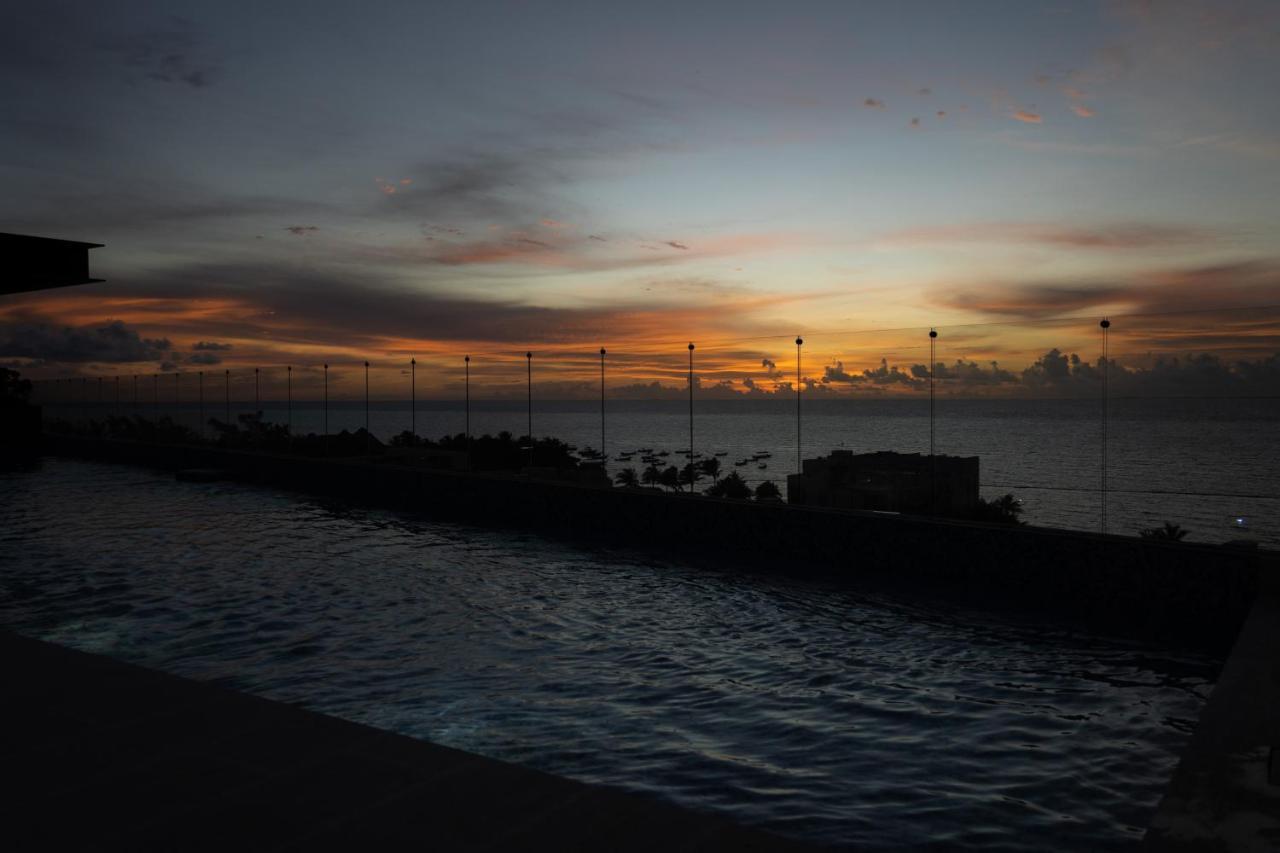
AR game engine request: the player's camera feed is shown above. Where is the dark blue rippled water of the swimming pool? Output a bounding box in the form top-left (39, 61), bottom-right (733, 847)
top-left (0, 460), bottom-right (1217, 849)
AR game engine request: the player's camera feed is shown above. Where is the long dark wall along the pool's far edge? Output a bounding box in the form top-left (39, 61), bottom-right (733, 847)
top-left (47, 437), bottom-right (1275, 651)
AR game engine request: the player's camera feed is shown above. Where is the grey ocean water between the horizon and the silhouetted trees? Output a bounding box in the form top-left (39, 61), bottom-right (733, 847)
top-left (40, 398), bottom-right (1280, 548)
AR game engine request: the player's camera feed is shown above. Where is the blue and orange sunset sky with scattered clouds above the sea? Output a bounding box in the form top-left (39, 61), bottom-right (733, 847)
top-left (0, 0), bottom-right (1280, 394)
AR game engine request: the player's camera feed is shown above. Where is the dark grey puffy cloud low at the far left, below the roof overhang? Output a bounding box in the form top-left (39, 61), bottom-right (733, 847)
top-left (0, 320), bottom-right (173, 362)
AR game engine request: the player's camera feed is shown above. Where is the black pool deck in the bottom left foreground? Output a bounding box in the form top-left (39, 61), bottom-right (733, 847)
top-left (0, 630), bottom-right (808, 850)
